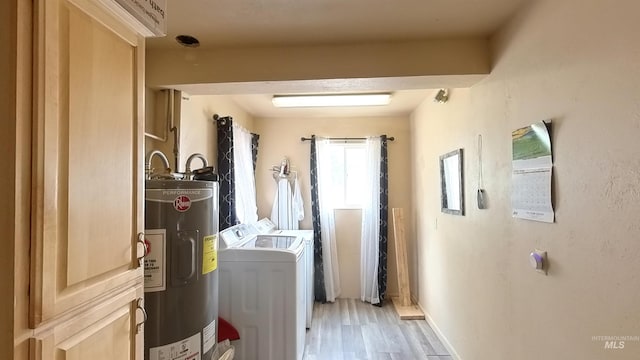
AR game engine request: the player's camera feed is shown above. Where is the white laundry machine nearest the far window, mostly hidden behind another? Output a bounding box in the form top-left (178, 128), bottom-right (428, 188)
top-left (252, 218), bottom-right (315, 329)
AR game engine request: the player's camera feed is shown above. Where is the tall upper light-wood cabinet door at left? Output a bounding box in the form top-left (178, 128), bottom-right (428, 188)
top-left (30, 0), bottom-right (144, 326)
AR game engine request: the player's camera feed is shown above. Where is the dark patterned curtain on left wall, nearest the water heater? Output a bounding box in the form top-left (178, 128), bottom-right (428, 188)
top-left (217, 116), bottom-right (237, 230)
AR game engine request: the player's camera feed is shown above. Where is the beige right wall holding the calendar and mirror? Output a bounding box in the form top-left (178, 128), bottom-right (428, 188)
top-left (411, 0), bottom-right (640, 360)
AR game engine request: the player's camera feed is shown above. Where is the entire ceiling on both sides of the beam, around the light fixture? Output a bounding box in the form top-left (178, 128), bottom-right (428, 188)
top-left (147, 0), bottom-right (526, 117)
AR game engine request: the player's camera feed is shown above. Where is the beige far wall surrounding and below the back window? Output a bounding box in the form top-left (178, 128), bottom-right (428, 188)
top-left (255, 117), bottom-right (415, 298)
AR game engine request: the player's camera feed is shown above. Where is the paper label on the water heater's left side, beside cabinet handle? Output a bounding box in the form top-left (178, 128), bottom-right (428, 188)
top-left (144, 229), bottom-right (167, 292)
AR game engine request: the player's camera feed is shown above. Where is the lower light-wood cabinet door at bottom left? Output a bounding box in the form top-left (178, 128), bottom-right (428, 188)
top-left (30, 286), bottom-right (144, 360)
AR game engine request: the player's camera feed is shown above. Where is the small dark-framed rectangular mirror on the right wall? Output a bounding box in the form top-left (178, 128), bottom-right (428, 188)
top-left (440, 149), bottom-right (464, 215)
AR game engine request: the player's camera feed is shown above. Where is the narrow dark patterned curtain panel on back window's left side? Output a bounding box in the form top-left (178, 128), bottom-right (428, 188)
top-left (309, 136), bottom-right (327, 303)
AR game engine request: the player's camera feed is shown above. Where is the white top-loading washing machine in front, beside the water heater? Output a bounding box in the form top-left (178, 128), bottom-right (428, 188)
top-left (218, 224), bottom-right (306, 360)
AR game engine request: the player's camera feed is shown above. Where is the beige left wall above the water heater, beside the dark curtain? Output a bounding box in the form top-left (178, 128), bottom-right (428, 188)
top-left (145, 92), bottom-right (253, 172)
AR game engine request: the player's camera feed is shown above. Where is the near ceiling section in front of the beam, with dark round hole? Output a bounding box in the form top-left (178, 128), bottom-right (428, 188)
top-left (148, 0), bottom-right (524, 48)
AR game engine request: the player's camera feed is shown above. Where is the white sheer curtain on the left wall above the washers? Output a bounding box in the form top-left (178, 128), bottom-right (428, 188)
top-left (233, 124), bottom-right (258, 224)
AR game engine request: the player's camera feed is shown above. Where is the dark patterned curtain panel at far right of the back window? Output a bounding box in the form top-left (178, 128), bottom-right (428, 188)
top-left (376, 135), bottom-right (389, 306)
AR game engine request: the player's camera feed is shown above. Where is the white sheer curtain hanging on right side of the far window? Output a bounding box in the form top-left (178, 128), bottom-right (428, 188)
top-left (360, 137), bottom-right (381, 304)
